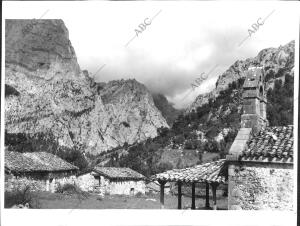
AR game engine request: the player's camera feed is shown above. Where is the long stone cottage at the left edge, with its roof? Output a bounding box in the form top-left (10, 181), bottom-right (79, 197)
top-left (4, 151), bottom-right (78, 192)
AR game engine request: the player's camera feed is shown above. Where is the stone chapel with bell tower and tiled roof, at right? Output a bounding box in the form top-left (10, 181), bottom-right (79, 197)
top-left (226, 68), bottom-right (294, 210)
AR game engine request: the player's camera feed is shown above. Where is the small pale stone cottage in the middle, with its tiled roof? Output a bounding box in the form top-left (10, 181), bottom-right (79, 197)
top-left (77, 166), bottom-right (145, 195)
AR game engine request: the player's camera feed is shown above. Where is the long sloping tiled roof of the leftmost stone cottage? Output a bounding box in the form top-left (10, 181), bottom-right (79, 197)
top-left (4, 151), bottom-right (78, 173)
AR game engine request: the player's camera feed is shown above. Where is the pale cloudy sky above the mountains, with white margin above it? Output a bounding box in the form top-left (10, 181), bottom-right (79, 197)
top-left (3, 1), bottom-right (299, 108)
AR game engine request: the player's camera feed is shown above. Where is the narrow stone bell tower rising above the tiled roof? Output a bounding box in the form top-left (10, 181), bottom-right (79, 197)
top-left (241, 67), bottom-right (268, 134)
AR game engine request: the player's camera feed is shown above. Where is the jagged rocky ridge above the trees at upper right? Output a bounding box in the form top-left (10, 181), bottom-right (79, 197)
top-left (186, 41), bottom-right (295, 112)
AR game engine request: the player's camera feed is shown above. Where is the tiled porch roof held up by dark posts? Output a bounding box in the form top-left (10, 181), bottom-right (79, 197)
top-left (152, 159), bottom-right (227, 183)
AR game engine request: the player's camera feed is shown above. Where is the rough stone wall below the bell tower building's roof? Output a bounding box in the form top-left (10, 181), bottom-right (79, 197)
top-left (228, 162), bottom-right (294, 210)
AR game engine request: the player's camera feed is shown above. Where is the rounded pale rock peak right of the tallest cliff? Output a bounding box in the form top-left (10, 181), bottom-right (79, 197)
top-left (85, 79), bottom-right (168, 153)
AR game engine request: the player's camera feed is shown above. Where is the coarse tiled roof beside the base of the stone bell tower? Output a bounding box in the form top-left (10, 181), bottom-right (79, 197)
top-left (241, 125), bottom-right (294, 163)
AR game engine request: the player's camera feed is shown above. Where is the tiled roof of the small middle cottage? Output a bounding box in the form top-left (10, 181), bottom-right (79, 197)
top-left (93, 166), bottom-right (145, 180)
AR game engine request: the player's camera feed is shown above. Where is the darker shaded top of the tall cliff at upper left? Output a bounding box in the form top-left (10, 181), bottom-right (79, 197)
top-left (5, 19), bottom-right (80, 79)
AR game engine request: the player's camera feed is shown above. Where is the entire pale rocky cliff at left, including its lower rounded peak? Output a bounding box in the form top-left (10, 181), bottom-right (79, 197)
top-left (5, 20), bottom-right (168, 154)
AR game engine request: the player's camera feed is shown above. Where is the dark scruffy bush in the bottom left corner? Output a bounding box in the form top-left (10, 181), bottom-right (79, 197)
top-left (4, 185), bottom-right (40, 209)
